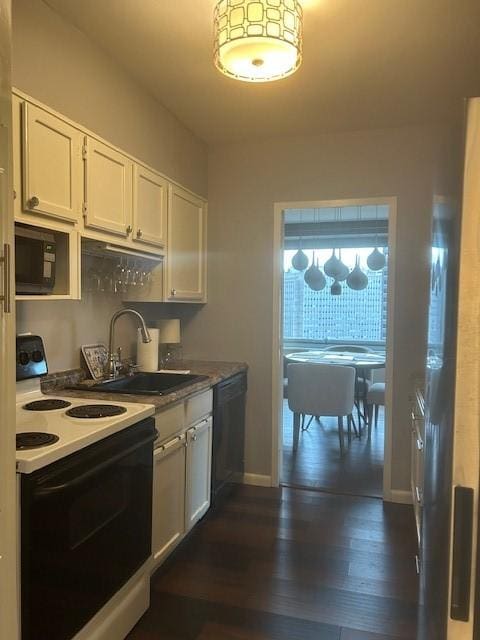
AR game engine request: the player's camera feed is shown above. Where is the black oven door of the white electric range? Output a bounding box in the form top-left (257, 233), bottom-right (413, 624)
top-left (21, 418), bottom-right (156, 640)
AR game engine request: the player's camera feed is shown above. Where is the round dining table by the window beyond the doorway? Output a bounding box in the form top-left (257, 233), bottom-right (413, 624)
top-left (285, 349), bottom-right (386, 442)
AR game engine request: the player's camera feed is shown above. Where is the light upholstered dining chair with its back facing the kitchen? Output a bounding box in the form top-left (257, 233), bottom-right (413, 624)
top-left (287, 362), bottom-right (355, 455)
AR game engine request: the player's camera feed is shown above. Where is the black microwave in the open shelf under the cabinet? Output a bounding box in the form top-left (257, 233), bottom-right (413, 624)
top-left (15, 225), bottom-right (56, 295)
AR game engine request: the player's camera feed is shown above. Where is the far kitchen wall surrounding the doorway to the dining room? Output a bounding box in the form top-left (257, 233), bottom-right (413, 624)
top-left (184, 127), bottom-right (458, 491)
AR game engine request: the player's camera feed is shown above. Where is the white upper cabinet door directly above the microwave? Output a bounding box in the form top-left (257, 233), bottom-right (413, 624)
top-left (22, 102), bottom-right (83, 222)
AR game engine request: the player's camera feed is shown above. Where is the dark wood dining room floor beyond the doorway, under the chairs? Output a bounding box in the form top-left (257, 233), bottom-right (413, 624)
top-left (282, 402), bottom-right (384, 497)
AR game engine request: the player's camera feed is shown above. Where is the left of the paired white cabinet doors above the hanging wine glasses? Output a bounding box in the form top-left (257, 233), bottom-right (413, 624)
top-left (84, 137), bottom-right (133, 237)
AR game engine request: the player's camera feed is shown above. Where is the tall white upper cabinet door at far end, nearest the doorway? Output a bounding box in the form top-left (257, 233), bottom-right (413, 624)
top-left (166, 185), bottom-right (207, 302)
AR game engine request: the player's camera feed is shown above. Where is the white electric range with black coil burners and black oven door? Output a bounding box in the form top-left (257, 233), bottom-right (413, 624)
top-left (16, 335), bottom-right (156, 640)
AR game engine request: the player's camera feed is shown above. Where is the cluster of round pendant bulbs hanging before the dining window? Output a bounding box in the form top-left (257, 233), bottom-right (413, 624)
top-left (292, 247), bottom-right (386, 296)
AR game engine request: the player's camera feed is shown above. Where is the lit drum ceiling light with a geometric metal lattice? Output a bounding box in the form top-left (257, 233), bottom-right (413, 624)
top-left (214, 0), bottom-right (303, 82)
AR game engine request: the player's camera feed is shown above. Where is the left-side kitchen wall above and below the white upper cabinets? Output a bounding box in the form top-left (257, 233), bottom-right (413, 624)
top-left (12, 0), bottom-right (207, 371)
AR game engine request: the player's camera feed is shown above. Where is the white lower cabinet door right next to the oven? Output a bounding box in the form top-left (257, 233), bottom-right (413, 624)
top-left (152, 435), bottom-right (186, 563)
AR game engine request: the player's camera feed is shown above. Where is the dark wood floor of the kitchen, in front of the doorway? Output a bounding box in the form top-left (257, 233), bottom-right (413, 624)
top-left (128, 486), bottom-right (417, 640)
